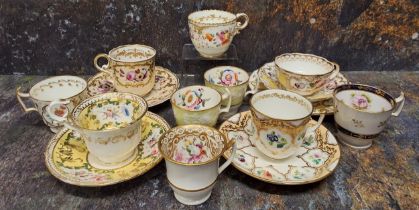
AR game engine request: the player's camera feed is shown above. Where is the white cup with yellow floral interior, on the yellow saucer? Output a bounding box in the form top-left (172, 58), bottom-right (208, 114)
top-left (47, 92), bottom-right (147, 169)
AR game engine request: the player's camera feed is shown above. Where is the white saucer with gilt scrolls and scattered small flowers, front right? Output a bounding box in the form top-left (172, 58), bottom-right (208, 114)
top-left (219, 111), bottom-right (340, 185)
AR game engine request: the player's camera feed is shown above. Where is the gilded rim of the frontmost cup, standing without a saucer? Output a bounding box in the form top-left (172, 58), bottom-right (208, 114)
top-left (158, 124), bottom-right (230, 166)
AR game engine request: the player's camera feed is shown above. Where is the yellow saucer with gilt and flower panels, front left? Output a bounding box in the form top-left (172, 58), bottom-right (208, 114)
top-left (45, 112), bottom-right (170, 187)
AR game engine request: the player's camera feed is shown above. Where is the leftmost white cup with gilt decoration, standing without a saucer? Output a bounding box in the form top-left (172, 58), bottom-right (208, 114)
top-left (16, 76), bottom-right (87, 133)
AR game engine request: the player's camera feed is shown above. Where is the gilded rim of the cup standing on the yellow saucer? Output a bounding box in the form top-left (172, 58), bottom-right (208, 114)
top-left (72, 92), bottom-right (148, 132)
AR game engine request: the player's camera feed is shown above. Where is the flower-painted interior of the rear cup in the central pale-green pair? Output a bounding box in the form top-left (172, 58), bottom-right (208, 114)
top-left (204, 66), bottom-right (249, 86)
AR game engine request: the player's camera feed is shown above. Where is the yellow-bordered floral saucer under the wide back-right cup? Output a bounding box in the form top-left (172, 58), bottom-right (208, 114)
top-left (249, 62), bottom-right (348, 102)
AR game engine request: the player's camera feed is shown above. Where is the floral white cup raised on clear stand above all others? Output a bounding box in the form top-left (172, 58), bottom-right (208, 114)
top-left (188, 10), bottom-right (249, 58)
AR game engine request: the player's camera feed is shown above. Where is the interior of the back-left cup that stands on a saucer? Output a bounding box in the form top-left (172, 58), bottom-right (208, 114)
top-left (109, 44), bottom-right (156, 62)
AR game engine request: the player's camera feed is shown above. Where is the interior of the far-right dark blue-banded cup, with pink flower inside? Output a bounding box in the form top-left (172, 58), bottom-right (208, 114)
top-left (335, 85), bottom-right (395, 113)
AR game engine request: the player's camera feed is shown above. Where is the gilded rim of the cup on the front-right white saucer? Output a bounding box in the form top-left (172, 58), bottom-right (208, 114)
top-left (249, 89), bottom-right (314, 121)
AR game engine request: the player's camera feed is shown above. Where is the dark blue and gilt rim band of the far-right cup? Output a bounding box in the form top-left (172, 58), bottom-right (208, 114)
top-left (333, 83), bottom-right (397, 114)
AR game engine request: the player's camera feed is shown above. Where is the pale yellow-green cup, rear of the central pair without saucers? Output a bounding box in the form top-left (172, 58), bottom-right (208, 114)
top-left (204, 66), bottom-right (249, 106)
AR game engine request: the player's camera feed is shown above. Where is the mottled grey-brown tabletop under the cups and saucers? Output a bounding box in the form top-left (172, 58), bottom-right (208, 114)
top-left (0, 71), bottom-right (419, 209)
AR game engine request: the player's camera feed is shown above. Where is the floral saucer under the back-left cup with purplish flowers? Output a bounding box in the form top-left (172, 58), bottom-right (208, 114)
top-left (87, 66), bottom-right (179, 107)
